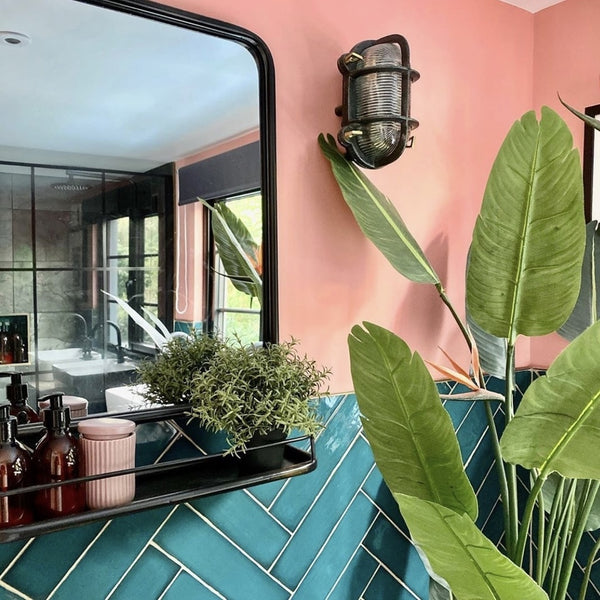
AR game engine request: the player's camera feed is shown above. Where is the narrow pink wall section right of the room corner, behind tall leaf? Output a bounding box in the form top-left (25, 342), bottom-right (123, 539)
top-left (531, 0), bottom-right (600, 366)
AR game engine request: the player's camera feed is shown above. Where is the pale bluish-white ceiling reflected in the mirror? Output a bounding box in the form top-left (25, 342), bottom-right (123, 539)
top-left (0, 0), bottom-right (259, 171)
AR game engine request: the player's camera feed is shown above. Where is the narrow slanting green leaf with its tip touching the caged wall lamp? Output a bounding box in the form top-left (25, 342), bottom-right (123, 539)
top-left (319, 134), bottom-right (440, 285)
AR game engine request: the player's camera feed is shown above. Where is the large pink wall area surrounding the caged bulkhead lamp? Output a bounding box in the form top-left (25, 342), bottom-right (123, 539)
top-left (162, 0), bottom-right (533, 392)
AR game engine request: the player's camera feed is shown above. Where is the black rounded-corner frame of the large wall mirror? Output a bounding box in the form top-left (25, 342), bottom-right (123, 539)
top-left (73, 0), bottom-right (279, 343)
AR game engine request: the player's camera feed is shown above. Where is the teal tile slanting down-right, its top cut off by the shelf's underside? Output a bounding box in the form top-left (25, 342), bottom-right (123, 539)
top-left (191, 491), bottom-right (289, 568)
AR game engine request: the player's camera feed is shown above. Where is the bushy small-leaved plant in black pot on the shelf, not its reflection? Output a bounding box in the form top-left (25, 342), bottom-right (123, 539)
top-left (190, 339), bottom-right (330, 469)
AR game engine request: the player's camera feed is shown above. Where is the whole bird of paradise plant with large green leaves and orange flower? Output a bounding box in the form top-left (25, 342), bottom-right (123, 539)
top-left (319, 107), bottom-right (600, 600)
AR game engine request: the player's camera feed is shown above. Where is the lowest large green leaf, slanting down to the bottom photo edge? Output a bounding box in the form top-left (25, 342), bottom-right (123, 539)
top-left (394, 494), bottom-right (547, 600)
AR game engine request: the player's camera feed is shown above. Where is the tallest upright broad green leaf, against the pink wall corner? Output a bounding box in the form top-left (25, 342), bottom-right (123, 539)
top-left (467, 107), bottom-right (585, 341)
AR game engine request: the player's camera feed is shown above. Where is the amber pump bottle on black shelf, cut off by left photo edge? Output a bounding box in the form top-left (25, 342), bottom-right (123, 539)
top-left (0, 402), bottom-right (33, 527)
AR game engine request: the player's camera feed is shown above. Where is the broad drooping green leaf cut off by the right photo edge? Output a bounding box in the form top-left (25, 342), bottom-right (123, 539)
top-left (500, 321), bottom-right (600, 479)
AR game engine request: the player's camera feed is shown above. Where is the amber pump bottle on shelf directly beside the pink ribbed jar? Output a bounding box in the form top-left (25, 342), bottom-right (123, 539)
top-left (33, 392), bottom-right (85, 519)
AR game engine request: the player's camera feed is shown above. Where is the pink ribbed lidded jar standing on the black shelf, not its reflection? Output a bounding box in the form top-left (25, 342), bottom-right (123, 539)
top-left (77, 417), bottom-right (135, 509)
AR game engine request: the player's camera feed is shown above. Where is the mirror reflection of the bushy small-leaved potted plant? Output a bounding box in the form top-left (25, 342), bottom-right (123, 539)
top-left (137, 330), bottom-right (224, 404)
